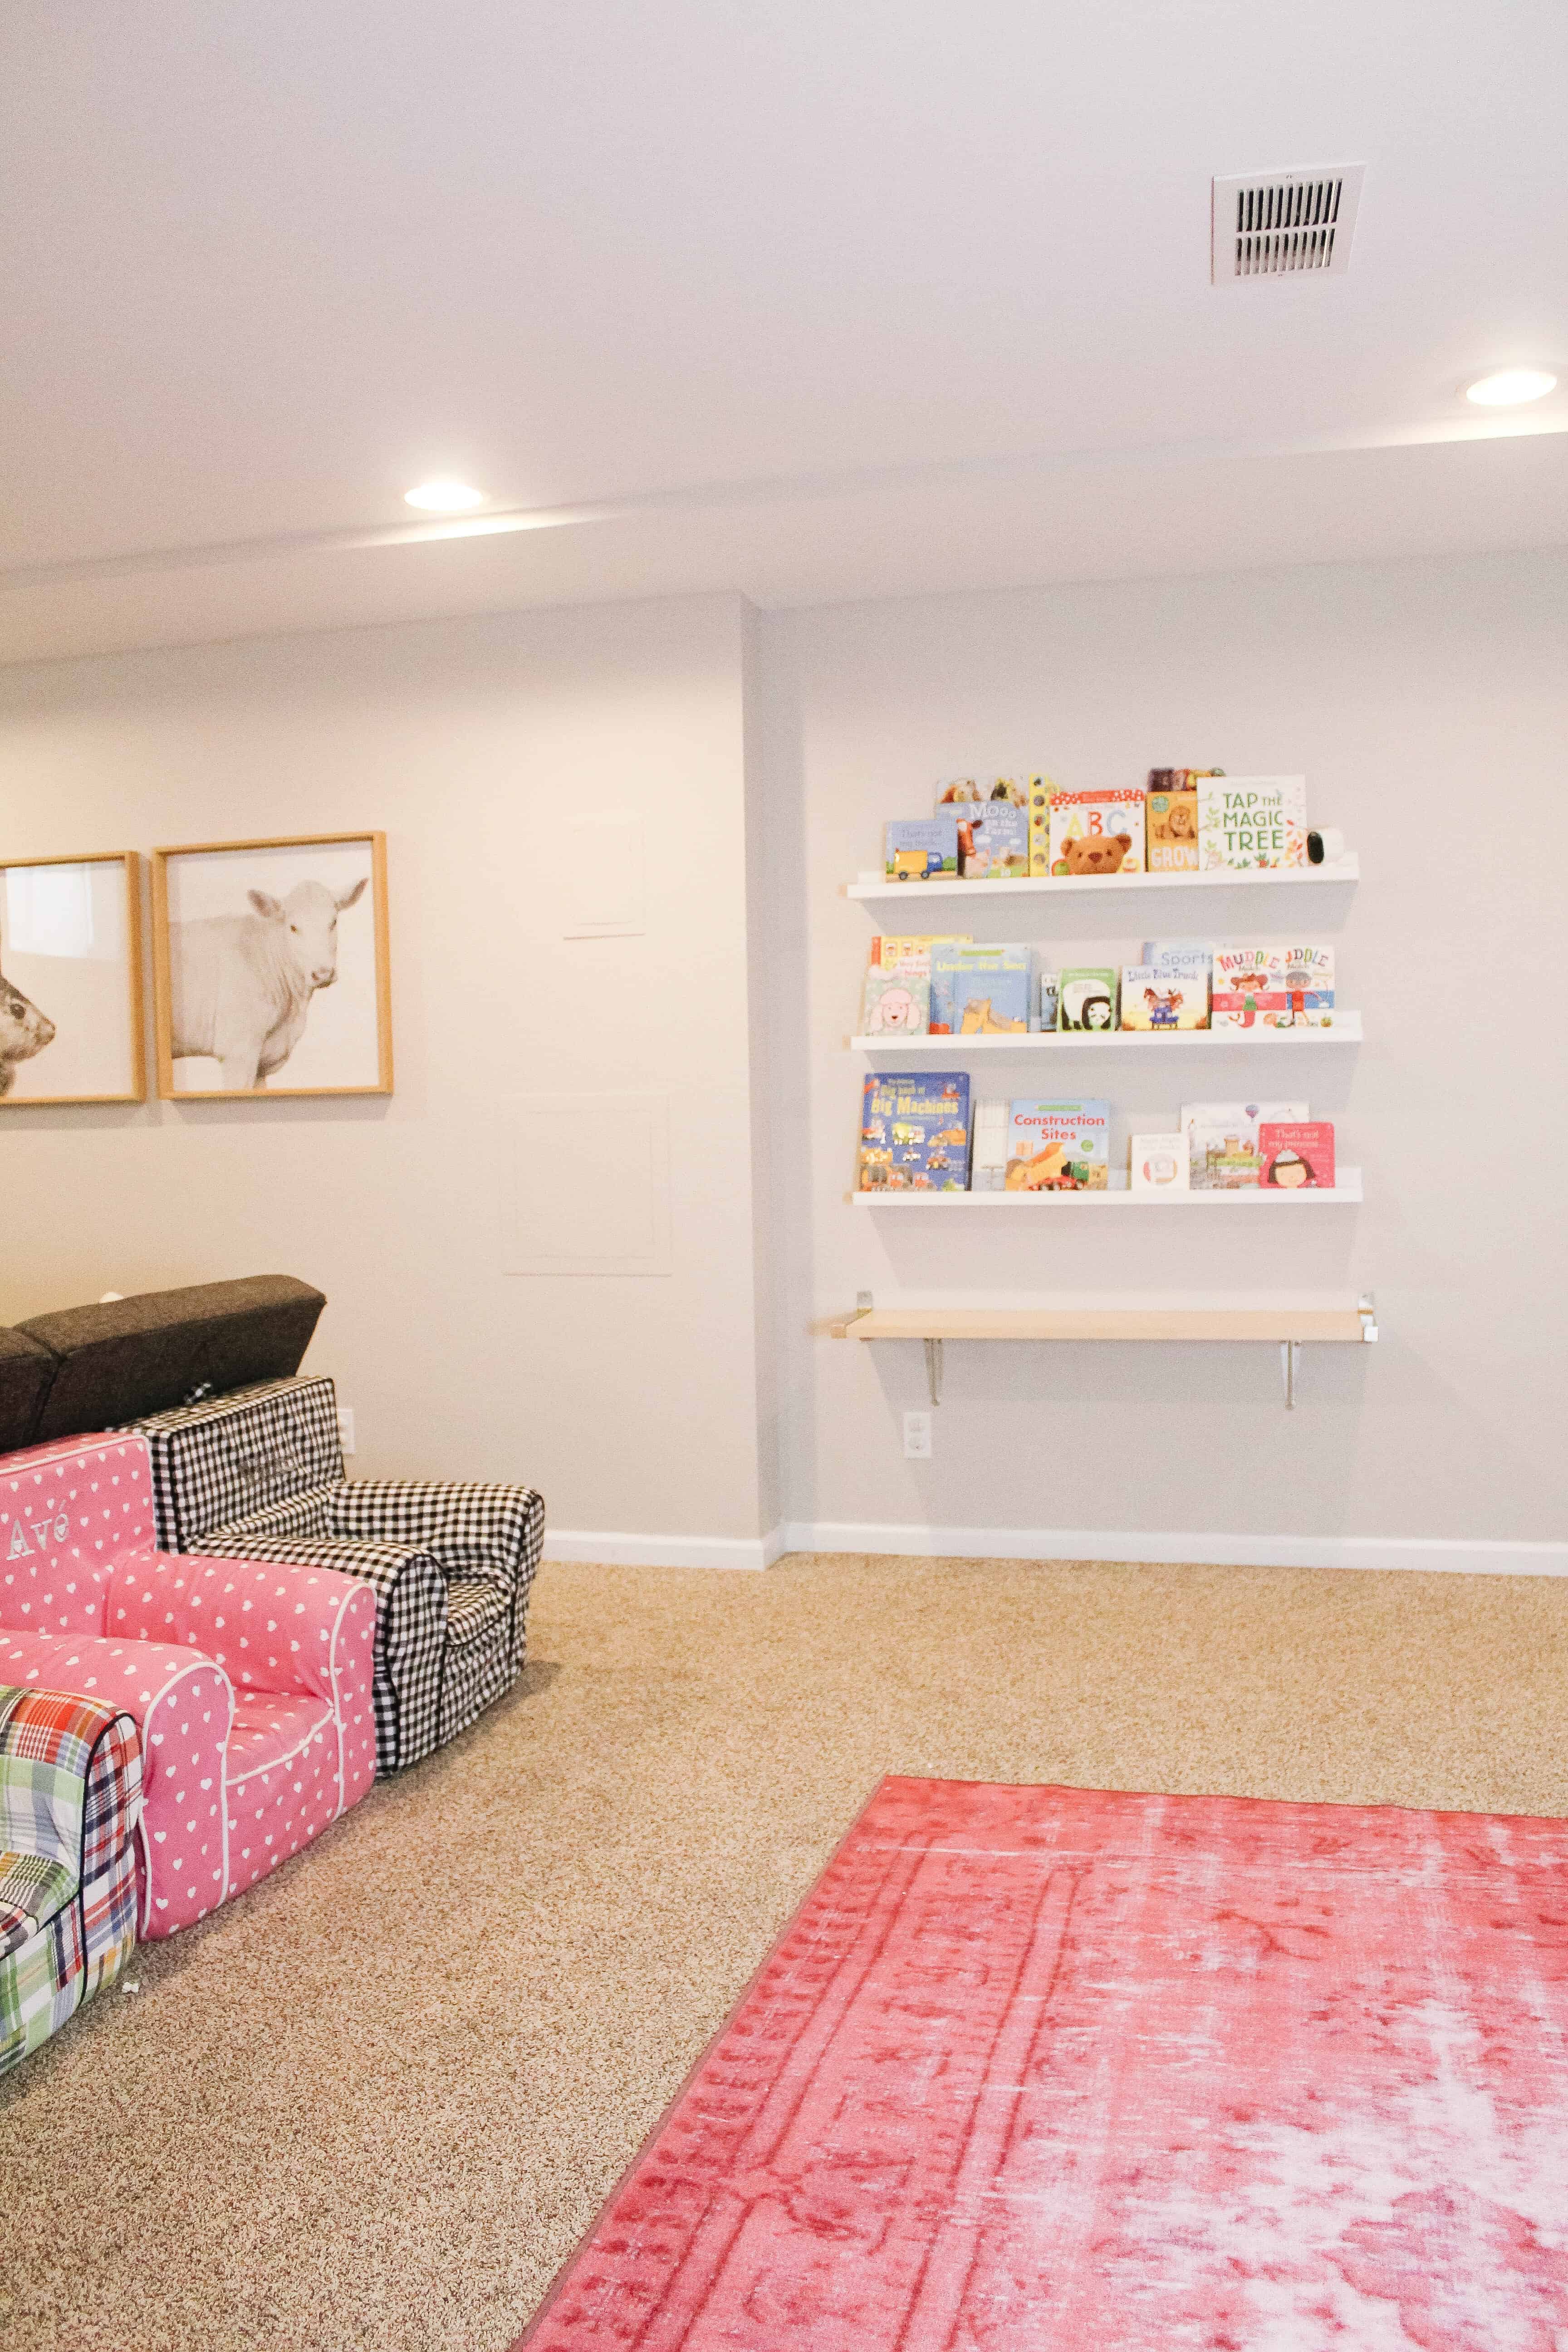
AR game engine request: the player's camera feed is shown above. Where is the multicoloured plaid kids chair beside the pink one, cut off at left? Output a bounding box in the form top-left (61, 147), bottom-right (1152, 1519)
top-left (0, 1684), bottom-right (141, 2074)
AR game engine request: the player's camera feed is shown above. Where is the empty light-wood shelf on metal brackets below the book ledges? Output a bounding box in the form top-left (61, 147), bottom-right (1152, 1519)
top-left (830, 1298), bottom-right (1377, 1406)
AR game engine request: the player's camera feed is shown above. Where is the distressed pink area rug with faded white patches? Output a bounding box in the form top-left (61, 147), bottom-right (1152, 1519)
top-left (522, 1780), bottom-right (1568, 2352)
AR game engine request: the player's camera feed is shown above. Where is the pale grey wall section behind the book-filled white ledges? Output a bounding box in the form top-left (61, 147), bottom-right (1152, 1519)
top-left (760, 555), bottom-right (1568, 1567)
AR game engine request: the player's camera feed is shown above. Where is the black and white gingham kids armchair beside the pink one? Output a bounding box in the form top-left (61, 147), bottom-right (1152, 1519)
top-left (132, 1378), bottom-right (545, 1774)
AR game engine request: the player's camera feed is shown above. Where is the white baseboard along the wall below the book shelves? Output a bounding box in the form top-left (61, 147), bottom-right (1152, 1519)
top-left (783, 1519), bottom-right (1568, 1576)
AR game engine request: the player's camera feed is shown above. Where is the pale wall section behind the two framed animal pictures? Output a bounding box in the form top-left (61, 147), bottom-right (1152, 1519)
top-left (0, 598), bottom-right (774, 1557)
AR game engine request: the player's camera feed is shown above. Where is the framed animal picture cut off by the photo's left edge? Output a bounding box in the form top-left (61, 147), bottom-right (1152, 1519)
top-left (0, 849), bottom-right (148, 1110)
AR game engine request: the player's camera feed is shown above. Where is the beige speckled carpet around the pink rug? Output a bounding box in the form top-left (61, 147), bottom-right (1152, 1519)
top-left (0, 1559), bottom-right (1568, 2352)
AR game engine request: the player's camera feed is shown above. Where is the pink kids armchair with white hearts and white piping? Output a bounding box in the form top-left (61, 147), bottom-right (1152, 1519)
top-left (0, 1411), bottom-right (376, 1936)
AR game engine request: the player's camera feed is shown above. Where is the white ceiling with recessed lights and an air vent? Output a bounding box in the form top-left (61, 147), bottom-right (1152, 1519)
top-left (0, 0), bottom-right (1568, 661)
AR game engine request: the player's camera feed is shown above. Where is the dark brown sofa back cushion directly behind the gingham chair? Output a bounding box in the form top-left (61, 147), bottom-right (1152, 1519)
top-left (16, 1275), bottom-right (327, 1442)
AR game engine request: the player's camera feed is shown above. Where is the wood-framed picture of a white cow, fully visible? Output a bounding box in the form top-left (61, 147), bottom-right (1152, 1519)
top-left (153, 833), bottom-right (392, 1101)
